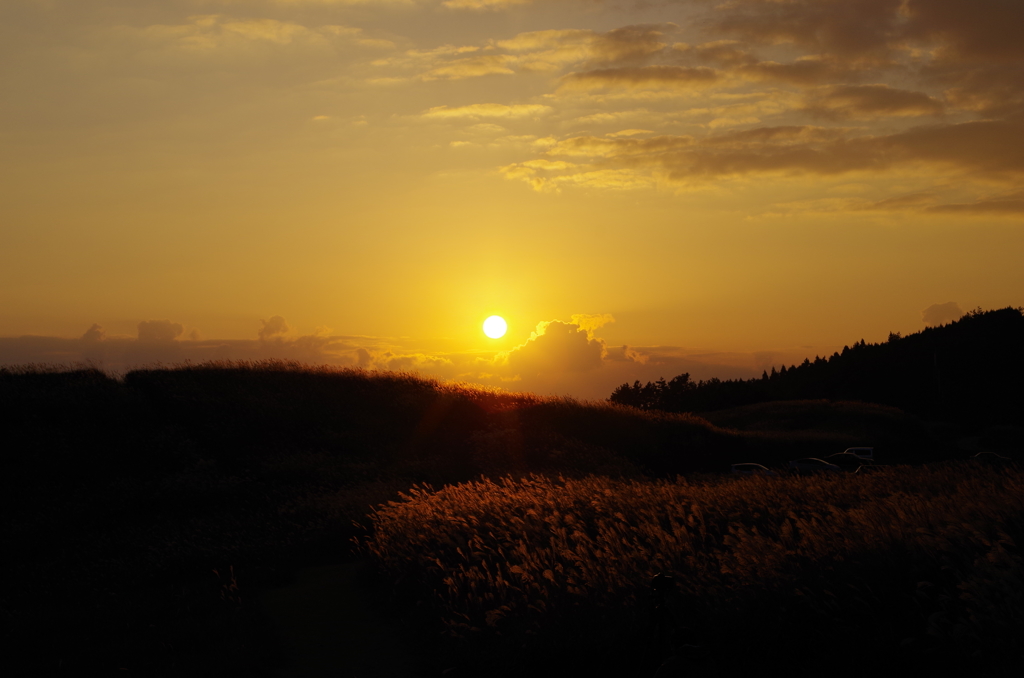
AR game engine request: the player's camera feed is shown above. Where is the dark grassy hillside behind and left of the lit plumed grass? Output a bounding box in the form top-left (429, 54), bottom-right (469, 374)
top-left (0, 362), bottom-right (999, 676)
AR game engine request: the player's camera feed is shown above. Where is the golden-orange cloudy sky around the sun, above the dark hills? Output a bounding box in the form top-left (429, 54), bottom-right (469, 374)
top-left (0, 0), bottom-right (1024, 397)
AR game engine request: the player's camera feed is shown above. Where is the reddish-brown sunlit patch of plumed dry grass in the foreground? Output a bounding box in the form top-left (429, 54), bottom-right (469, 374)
top-left (361, 463), bottom-right (1024, 675)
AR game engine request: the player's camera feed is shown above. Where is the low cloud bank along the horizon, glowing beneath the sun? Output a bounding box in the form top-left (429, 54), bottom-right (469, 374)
top-left (0, 313), bottom-right (782, 398)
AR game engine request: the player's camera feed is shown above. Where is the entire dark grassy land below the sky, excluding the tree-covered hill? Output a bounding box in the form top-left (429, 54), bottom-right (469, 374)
top-left (0, 363), bottom-right (1024, 678)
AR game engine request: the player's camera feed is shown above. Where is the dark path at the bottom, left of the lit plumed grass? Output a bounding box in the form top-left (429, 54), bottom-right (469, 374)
top-left (259, 561), bottom-right (417, 678)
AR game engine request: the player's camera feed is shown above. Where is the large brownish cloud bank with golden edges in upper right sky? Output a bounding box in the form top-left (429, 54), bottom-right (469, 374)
top-left (466, 0), bottom-right (1024, 209)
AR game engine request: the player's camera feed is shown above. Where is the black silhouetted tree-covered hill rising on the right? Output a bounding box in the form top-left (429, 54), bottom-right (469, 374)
top-left (608, 307), bottom-right (1024, 425)
